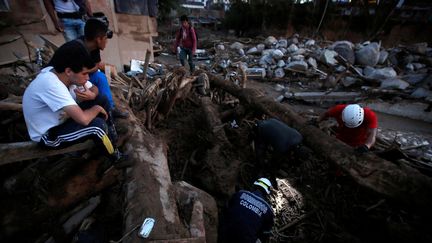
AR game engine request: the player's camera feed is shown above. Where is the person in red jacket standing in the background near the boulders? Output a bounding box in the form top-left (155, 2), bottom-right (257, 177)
top-left (173, 15), bottom-right (197, 73)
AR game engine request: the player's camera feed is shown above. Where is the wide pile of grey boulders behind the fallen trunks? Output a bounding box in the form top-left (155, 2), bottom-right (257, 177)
top-left (205, 35), bottom-right (432, 103)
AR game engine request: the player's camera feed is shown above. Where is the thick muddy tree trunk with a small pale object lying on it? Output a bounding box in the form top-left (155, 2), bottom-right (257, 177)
top-left (123, 112), bottom-right (190, 242)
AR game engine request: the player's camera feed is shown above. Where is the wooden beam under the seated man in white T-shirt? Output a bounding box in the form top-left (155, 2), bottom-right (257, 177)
top-left (0, 140), bottom-right (94, 165)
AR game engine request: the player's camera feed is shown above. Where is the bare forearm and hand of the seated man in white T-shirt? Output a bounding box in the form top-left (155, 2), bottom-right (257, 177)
top-left (63, 105), bottom-right (108, 126)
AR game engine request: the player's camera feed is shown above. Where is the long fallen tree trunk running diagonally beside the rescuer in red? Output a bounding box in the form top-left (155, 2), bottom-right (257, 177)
top-left (208, 74), bottom-right (432, 210)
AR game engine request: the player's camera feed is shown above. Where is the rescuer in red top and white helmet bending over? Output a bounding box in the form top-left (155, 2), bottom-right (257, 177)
top-left (318, 104), bottom-right (378, 153)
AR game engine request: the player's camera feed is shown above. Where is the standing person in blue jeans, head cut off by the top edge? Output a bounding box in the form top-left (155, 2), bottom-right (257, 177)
top-left (43, 0), bottom-right (93, 42)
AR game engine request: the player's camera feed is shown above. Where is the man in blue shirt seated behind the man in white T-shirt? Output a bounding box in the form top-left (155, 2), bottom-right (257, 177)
top-left (48, 13), bottom-right (129, 118)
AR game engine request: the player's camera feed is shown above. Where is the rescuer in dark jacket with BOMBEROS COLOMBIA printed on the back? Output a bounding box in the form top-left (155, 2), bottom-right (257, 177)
top-left (219, 178), bottom-right (274, 243)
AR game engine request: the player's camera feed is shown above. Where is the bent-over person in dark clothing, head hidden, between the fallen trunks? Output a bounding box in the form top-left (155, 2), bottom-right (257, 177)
top-left (252, 118), bottom-right (303, 169)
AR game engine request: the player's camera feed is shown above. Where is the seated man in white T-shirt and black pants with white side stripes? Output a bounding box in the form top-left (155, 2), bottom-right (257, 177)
top-left (23, 42), bottom-right (126, 163)
